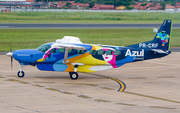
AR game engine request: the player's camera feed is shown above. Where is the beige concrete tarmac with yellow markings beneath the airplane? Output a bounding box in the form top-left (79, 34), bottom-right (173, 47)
top-left (0, 52), bottom-right (180, 113)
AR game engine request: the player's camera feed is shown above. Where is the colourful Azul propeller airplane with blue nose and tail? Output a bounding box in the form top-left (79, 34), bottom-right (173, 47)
top-left (6, 20), bottom-right (173, 80)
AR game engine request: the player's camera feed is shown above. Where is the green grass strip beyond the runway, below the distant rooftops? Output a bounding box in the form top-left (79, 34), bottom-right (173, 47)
top-left (0, 12), bottom-right (180, 23)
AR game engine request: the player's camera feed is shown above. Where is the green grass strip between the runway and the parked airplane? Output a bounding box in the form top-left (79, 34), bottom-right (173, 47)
top-left (0, 29), bottom-right (180, 51)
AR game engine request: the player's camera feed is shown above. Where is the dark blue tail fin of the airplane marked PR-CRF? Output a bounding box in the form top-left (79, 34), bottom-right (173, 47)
top-left (128, 20), bottom-right (173, 51)
